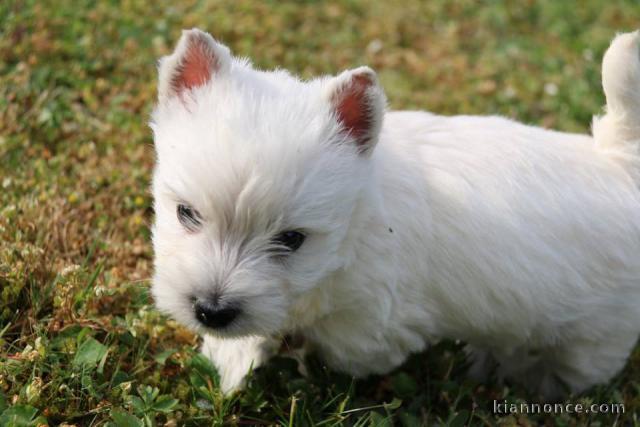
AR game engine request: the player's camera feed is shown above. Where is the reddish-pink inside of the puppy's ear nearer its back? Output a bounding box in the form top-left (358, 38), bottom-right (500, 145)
top-left (336, 75), bottom-right (373, 145)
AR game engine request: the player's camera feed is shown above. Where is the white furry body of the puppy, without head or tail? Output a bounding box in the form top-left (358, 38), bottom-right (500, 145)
top-left (294, 113), bottom-right (640, 394)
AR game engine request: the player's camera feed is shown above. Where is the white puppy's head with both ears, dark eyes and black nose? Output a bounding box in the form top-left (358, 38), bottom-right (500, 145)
top-left (151, 29), bottom-right (385, 336)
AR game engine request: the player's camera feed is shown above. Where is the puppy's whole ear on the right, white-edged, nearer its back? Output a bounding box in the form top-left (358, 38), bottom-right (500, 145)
top-left (326, 67), bottom-right (386, 153)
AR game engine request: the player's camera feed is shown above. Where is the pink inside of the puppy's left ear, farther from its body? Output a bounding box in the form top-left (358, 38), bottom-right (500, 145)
top-left (172, 38), bottom-right (215, 93)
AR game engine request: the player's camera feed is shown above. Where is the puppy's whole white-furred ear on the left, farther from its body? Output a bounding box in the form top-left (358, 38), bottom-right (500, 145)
top-left (158, 28), bottom-right (231, 103)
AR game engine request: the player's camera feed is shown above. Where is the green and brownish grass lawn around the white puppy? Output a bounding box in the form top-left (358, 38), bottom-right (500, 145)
top-left (0, 0), bottom-right (640, 426)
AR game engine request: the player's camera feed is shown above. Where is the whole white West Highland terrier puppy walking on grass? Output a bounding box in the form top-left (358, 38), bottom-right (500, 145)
top-left (151, 29), bottom-right (640, 398)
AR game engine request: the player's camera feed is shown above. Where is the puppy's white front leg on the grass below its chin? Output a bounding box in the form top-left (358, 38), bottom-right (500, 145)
top-left (202, 335), bottom-right (280, 394)
